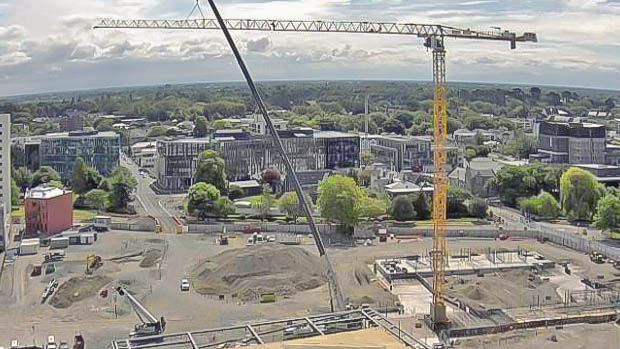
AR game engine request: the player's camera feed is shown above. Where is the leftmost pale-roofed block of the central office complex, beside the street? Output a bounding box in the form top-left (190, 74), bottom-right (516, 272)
top-left (155, 139), bottom-right (213, 192)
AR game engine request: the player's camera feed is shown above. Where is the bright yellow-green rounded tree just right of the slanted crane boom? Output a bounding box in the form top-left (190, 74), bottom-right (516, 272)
top-left (317, 175), bottom-right (363, 227)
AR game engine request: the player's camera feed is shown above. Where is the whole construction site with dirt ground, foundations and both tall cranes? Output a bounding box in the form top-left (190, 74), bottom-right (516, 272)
top-left (0, 0), bottom-right (620, 349)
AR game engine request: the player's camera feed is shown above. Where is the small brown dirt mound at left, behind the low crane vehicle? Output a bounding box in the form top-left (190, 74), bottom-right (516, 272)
top-left (50, 276), bottom-right (112, 309)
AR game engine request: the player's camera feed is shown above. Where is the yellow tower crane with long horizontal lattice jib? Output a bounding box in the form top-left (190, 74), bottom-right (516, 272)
top-left (94, 7), bottom-right (538, 328)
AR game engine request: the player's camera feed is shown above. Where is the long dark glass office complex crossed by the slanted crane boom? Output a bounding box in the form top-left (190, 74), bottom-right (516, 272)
top-left (155, 129), bottom-right (360, 192)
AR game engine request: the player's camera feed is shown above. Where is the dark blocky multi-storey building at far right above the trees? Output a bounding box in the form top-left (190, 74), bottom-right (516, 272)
top-left (531, 121), bottom-right (606, 164)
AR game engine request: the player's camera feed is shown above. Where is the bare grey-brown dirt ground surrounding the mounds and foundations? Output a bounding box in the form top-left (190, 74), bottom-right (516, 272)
top-left (0, 232), bottom-right (616, 348)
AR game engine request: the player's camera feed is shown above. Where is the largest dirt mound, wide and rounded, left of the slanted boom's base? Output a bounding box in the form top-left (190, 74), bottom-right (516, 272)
top-left (192, 245), bottom-right (326, 301)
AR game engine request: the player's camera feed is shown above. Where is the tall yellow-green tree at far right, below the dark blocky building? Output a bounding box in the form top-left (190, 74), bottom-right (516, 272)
top-left (560, 167), bottom-right (603, 220)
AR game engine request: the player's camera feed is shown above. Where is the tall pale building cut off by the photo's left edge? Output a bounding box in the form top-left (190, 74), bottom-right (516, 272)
top-left (0, 114), bottom-right (11, 230)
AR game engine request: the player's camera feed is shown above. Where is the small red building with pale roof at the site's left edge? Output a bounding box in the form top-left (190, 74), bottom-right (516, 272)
top-left (24, 186), bottom-right (73, 237)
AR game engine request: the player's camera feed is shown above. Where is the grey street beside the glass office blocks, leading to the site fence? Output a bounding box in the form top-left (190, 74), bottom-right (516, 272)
top-left (121, 156), bottom-right (176, 233)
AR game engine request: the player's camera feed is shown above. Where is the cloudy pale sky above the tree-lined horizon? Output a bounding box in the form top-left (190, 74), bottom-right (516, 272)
top-left (0, 0), bottom-right (620, 96)
